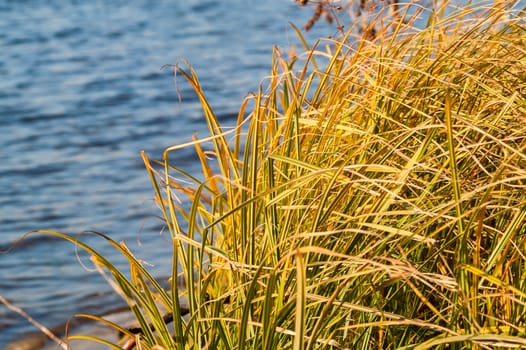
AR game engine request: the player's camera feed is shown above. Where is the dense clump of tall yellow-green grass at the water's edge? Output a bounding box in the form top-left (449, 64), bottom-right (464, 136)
top-left (17, 4), bottom-right (526, 350)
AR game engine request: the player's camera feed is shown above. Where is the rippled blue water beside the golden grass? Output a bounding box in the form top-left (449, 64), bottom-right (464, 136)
top-left (0, 0), bottom-right (335, 348)
